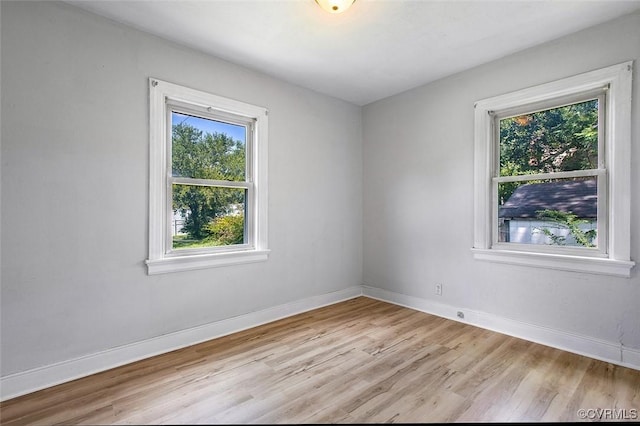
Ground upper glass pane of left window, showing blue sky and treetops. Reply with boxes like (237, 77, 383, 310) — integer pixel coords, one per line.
(171, 111, 247, 181)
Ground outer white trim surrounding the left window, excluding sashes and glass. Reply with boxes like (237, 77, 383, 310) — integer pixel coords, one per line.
(145, 78, 269, 275)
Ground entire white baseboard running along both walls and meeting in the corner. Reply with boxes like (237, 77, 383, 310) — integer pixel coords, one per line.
(0, 286, 640, 401)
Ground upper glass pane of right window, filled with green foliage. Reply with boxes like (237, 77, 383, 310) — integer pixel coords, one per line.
(500, 99, 598, 176)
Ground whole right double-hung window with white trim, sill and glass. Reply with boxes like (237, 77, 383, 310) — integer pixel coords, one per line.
(473, 62, 634, 276)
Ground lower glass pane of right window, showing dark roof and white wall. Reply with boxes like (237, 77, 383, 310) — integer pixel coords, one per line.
(498, 177, 598, 247)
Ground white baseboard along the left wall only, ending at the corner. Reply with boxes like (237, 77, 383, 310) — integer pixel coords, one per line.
(0, 286, 362, 401)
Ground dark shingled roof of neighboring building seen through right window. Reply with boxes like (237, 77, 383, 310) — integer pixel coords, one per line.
(498, 179, 598, 219)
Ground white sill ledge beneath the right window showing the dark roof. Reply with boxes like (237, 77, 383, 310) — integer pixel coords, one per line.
(471, 248, 635, 278)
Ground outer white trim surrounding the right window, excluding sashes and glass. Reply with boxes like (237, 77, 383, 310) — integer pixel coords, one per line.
(472, 61, 635, 277)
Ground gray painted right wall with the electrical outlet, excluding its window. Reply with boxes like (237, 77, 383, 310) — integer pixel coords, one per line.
(363, 13, 640, 348)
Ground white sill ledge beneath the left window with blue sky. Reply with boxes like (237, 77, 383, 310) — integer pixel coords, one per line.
(145, 250, 270, 275)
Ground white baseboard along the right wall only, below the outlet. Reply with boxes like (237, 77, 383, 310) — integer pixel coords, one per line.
(362, 286, 640, 370)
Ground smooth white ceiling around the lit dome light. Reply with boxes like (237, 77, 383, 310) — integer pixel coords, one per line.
(68, 0, 640, 105)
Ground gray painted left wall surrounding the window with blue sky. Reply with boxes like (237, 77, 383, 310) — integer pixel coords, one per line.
(1, 2, 362, 376)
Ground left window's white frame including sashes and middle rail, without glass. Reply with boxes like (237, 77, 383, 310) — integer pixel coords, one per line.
(146, 78, 269, 275)
